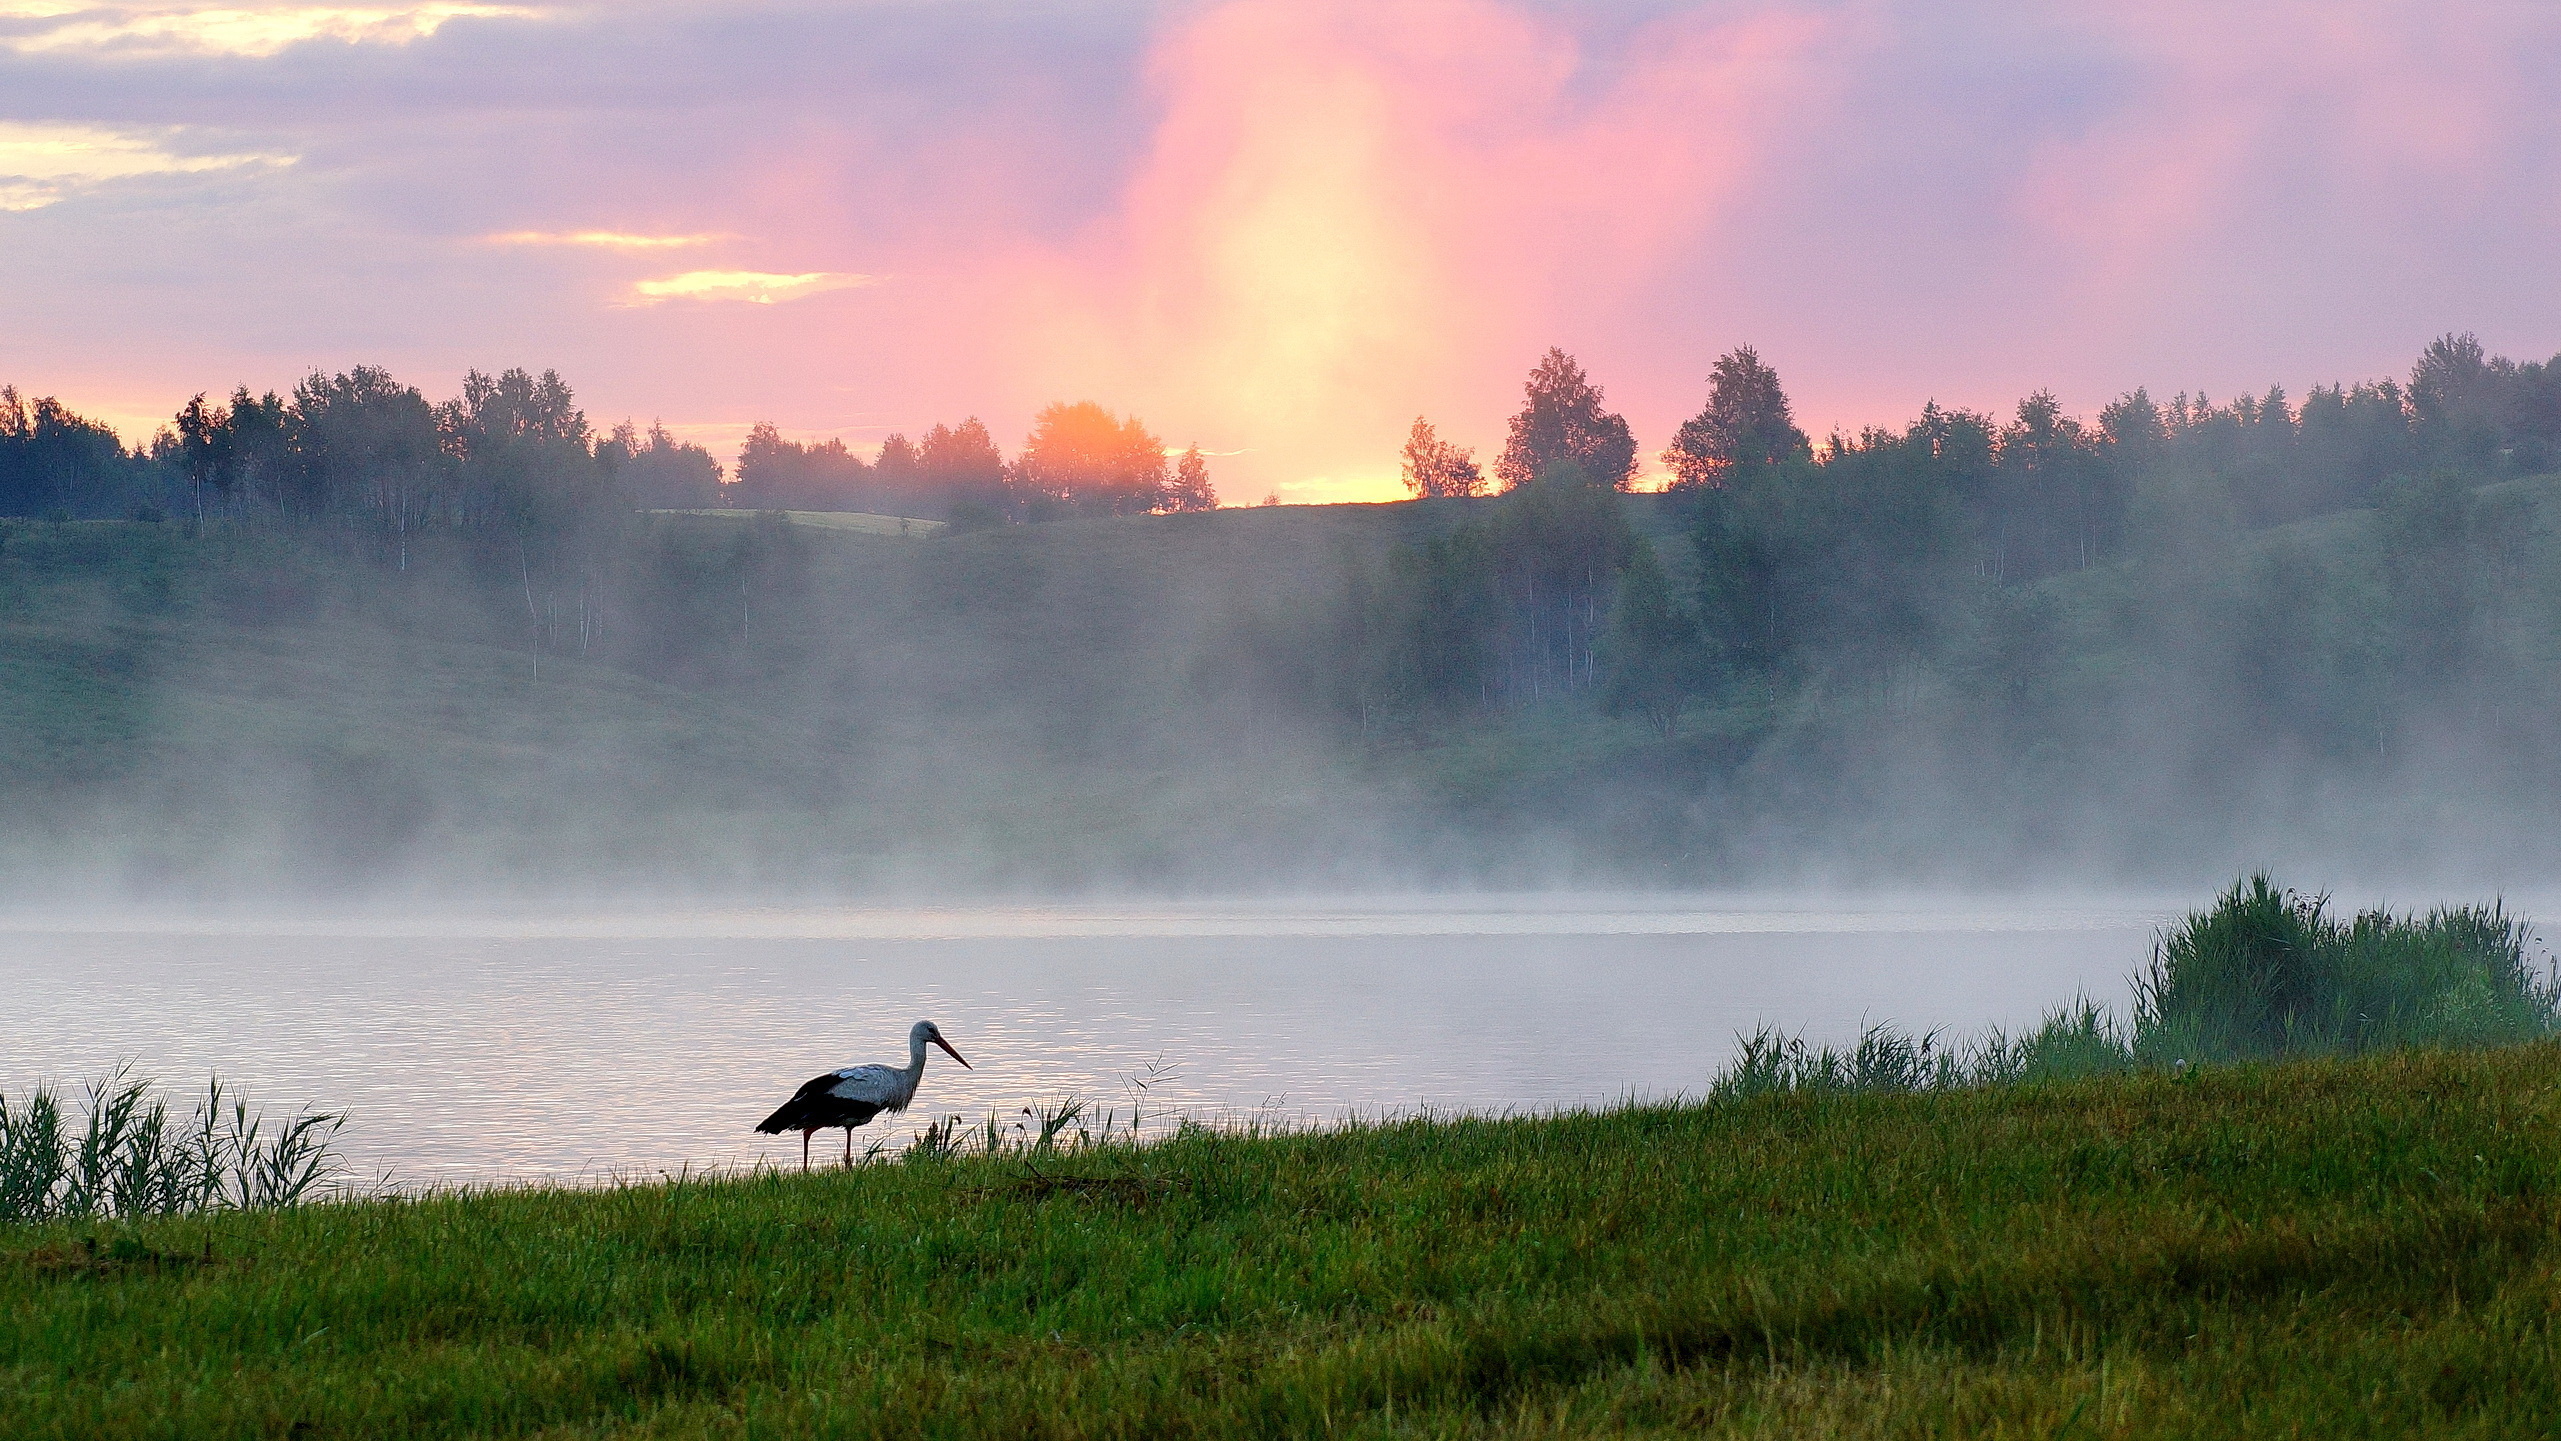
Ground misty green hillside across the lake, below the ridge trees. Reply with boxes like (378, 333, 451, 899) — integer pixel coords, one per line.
(15, 476, 2561, 898)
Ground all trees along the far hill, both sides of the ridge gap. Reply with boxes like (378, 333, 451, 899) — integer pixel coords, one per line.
(0, 325, 2561, 752)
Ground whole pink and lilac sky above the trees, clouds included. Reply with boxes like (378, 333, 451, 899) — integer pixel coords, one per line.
(0, 0, 2561, 502)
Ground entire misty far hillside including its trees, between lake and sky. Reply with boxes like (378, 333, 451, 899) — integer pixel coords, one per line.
(0, 335, 2561, 888)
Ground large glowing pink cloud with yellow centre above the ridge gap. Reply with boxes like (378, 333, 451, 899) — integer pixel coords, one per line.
(962, 0, 1831, 499)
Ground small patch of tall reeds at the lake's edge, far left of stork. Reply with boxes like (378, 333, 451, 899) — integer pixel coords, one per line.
(0, 1067, 346, 1223)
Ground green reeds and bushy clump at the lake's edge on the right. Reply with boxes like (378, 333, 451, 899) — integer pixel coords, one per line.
(1711, 873, 2561, 1098)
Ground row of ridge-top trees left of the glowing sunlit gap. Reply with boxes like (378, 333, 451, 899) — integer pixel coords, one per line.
(0, 366, 1216, 529)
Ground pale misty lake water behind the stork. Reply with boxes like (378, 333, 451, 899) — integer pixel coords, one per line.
(0, 896, 2169, 1182)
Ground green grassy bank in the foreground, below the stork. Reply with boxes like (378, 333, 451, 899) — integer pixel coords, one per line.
(0, 1047, 2561, 1438)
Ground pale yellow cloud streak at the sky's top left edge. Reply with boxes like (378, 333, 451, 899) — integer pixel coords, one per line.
(0, 0, 543, 56)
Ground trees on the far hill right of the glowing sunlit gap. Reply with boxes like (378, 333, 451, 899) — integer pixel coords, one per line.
(1337, 335, 2561, 732)
